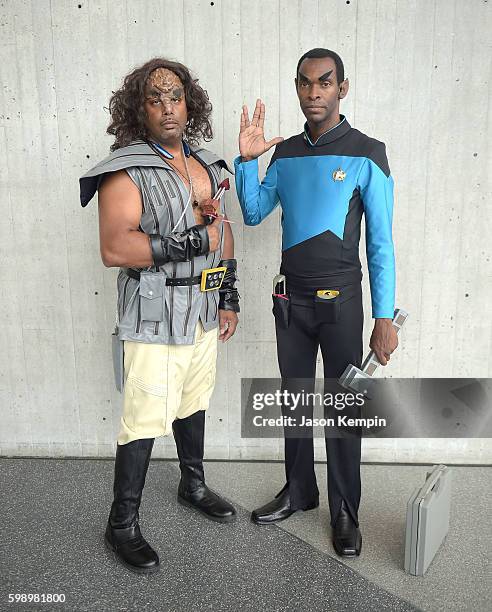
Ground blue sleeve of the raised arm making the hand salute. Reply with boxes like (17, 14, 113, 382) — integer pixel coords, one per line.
(234, 157, 279, 225)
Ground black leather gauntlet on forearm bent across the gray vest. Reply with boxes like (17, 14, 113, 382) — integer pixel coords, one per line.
(149, 225, 210, 267)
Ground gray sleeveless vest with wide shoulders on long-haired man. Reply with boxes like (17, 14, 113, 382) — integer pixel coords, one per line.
(80, 141, 231, 344)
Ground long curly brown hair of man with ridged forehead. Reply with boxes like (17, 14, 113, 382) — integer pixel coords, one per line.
(106, 57, 213, 151)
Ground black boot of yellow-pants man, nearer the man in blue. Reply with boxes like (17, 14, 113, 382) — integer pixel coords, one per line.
(173, 410, 236, 523)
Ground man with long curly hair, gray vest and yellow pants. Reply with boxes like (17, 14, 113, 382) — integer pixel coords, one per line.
(80, 58, 239, 573)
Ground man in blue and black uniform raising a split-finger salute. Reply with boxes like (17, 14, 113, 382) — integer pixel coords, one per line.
(235, 49, 398, 556)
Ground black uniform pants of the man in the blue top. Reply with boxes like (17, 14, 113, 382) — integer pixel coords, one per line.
(275, 285, 363, 526)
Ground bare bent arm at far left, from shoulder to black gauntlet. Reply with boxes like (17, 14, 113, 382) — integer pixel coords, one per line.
(99, 170, 153, 268)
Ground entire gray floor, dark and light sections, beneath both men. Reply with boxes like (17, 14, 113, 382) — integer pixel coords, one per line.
(0, 458, 491, 612)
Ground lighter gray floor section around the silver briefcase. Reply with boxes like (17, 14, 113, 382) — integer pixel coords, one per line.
(207, 463, 492, 612)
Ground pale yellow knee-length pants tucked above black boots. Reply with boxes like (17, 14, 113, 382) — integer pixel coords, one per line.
(117, 321, 218, 445)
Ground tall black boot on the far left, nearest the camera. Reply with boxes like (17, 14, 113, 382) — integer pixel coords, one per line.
(104, 438, 159, 574)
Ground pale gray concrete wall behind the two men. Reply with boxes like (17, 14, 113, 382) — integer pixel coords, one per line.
(0, 0, 492, 463)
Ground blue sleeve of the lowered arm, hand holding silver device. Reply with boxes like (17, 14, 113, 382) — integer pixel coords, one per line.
(359, 148, 395, 319)
